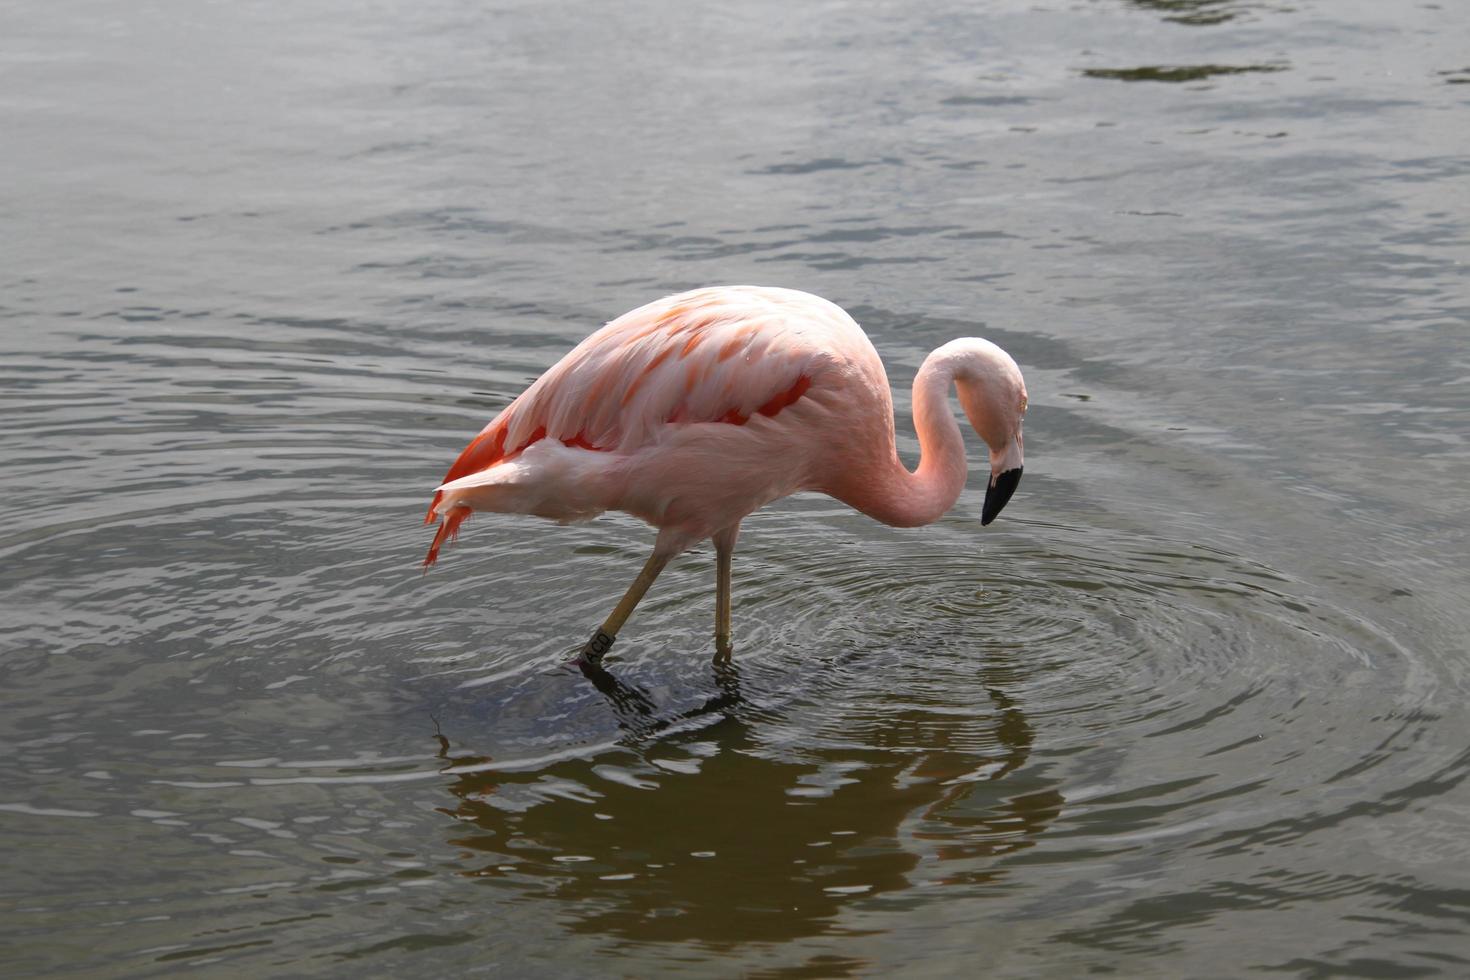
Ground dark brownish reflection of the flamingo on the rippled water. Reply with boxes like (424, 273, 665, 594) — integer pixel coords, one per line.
(426, 646, 1063, 945)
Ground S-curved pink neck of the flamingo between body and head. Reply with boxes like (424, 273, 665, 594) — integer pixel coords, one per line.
(842, 351, 970, 527)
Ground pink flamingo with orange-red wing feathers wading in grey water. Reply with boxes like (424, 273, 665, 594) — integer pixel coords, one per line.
(423, 287, 1026, 667)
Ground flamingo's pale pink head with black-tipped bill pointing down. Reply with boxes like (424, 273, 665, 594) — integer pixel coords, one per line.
(954, 345, 1026, 525)
